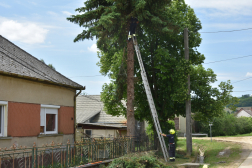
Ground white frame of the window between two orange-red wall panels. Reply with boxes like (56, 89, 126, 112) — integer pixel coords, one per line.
(40, 104, 60, 134)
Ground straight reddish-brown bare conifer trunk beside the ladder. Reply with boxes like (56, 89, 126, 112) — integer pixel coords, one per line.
(127, 39, 135, 137)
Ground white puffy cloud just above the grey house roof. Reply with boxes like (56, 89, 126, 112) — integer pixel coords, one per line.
(0, 18, 48, 44)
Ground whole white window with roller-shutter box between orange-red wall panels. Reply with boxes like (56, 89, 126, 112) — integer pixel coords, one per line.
(40, 104, 60, 134)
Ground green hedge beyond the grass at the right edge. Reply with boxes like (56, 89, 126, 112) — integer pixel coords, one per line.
(197, 113, 252, 136)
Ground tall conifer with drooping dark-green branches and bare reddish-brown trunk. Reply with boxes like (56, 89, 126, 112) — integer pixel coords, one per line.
(67, 0, 175, 136)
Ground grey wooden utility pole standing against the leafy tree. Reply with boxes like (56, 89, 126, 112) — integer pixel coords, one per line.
(184, 28, 192, 156)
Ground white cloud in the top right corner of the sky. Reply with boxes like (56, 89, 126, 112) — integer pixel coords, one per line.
(185, 0, 252, 16)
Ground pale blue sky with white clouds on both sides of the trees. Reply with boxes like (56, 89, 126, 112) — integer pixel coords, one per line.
(0, 0, 252, 97)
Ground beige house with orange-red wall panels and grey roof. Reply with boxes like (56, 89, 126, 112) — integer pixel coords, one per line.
(0, 36, 85, 148)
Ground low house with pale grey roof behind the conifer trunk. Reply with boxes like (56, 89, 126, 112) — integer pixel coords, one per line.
(76, 95, 147, 140)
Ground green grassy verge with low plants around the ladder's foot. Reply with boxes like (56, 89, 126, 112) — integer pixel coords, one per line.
(102, 139, 242, 168)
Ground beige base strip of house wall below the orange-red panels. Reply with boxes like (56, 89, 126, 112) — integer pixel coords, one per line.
(0, 134, 74, 148)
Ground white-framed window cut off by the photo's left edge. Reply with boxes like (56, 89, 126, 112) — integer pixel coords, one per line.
(0, 101, 8, 137)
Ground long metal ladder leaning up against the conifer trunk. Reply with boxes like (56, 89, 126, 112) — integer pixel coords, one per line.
(132, 37, 169, 162)
